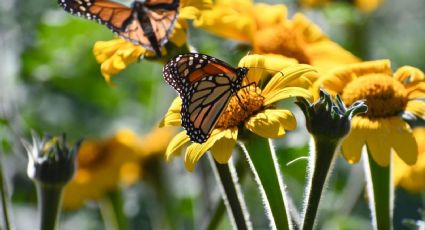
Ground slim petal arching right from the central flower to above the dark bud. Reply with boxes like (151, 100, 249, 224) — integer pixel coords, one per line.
(263, 87, 313, 106)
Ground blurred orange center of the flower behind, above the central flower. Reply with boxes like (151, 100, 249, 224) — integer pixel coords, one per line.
(254, 25, 310, 64)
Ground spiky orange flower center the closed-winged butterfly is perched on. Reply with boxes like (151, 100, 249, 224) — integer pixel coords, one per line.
(216, 86, 264, 129)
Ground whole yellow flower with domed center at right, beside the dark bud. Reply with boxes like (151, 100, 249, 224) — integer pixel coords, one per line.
(315, 60, 425, 166)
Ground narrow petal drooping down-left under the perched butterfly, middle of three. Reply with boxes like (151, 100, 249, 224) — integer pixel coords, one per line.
(184, 129, 225, 172)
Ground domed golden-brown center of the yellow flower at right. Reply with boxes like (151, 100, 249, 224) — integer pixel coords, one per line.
(342, 74, 408, 118)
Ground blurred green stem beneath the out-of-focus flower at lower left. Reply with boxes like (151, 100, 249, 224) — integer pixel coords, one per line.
(99, 188, 128, 230)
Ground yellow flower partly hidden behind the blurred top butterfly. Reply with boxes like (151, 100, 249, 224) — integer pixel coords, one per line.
(93, 0, 211, 82)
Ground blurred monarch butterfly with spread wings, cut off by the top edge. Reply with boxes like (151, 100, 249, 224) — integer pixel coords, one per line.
(58, 0, 179, 57)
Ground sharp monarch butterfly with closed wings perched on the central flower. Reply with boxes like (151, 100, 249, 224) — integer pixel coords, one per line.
(163, 53, 248, 143)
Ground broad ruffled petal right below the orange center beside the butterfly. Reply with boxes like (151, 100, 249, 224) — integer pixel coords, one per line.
(245, 109, 297, 138)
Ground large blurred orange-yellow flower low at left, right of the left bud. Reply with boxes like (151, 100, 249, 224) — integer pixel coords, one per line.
(63, 129, 174, 209)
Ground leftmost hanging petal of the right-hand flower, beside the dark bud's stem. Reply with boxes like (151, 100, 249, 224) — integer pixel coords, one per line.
(342, 126, 365, 164)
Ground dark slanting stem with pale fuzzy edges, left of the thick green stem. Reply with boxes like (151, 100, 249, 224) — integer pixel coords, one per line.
(209, 156, 251, 230)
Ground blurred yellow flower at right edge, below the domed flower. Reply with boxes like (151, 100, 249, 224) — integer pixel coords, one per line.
(394, 128, 425, 192)
